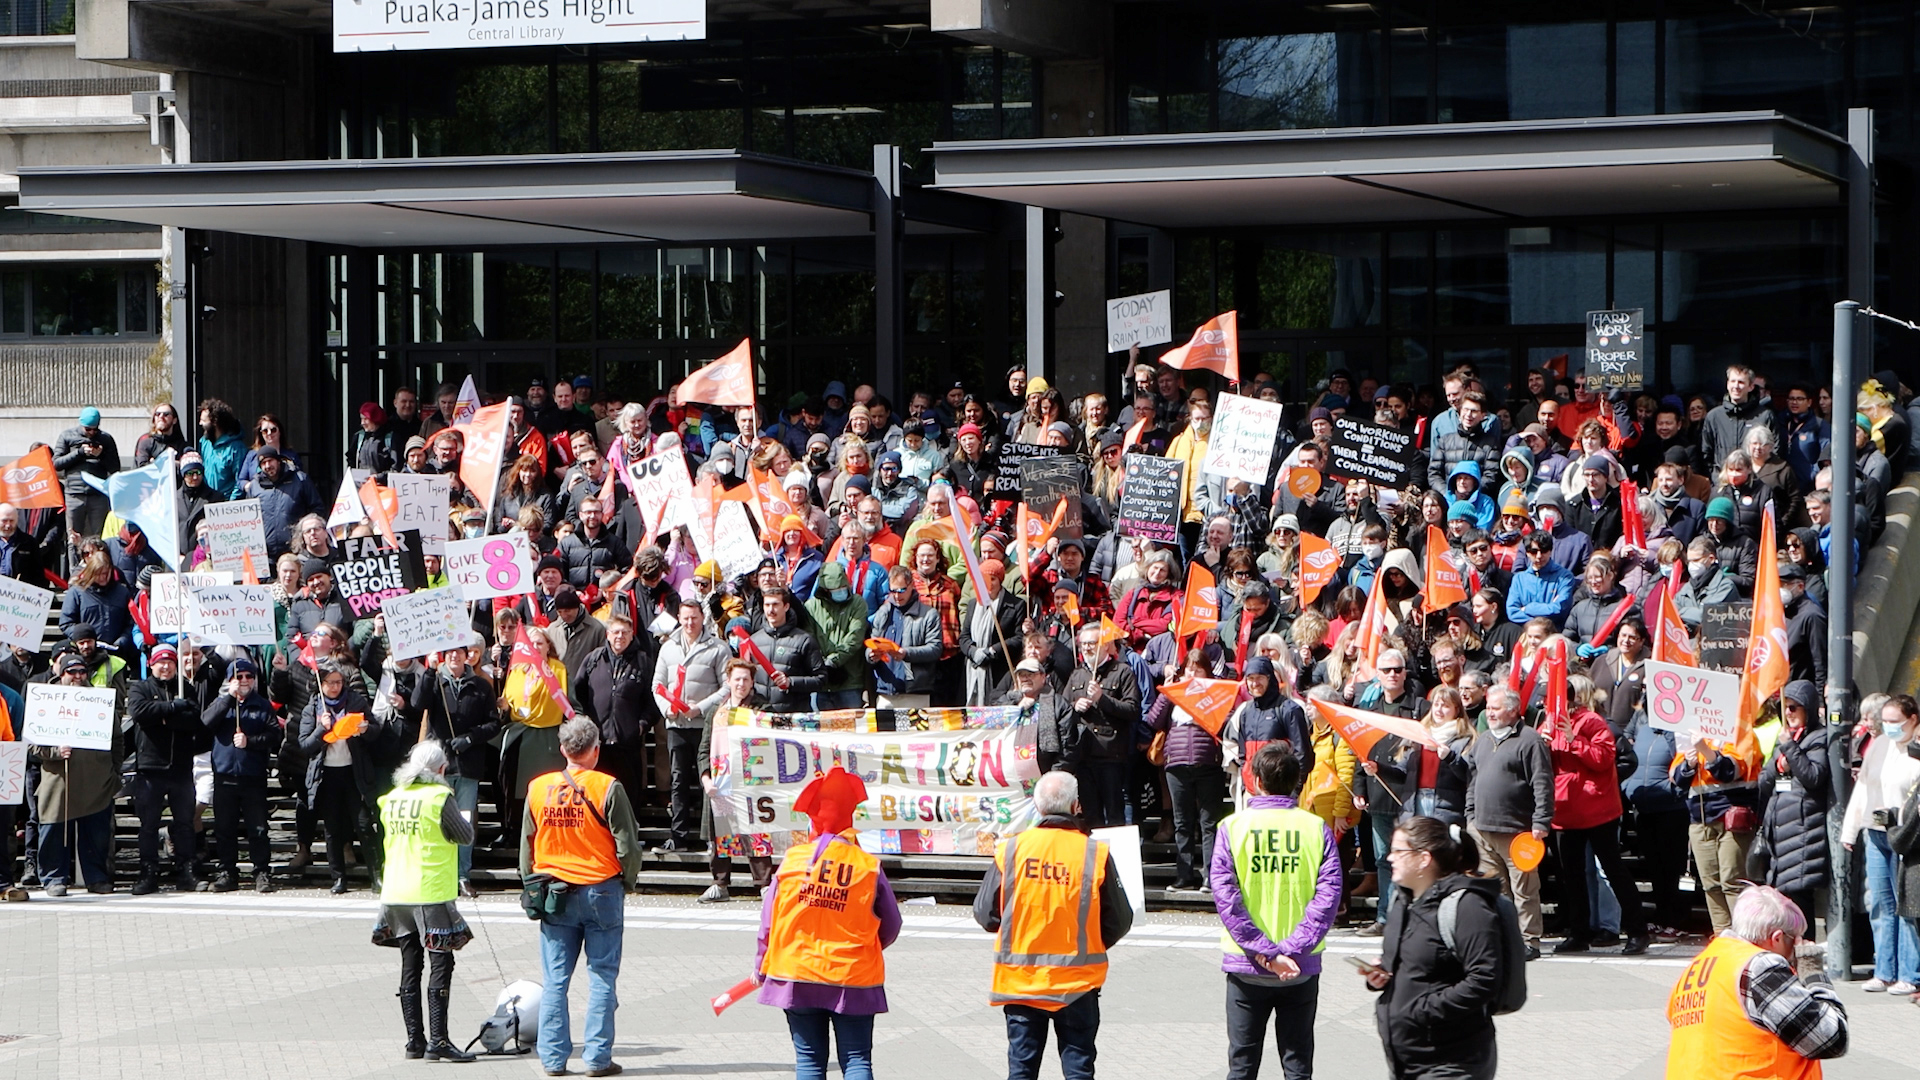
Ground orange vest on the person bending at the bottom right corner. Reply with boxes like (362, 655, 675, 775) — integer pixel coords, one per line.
(1667, 936, 1820, 1080)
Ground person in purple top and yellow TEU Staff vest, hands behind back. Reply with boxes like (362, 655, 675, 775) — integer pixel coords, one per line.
(1210, 742, 1340, 1080)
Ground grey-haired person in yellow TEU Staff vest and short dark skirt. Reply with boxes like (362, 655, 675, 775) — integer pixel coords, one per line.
(372, 738, 474, 1061)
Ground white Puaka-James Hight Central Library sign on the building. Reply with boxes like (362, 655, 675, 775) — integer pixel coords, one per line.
(334, 0, 707, 52)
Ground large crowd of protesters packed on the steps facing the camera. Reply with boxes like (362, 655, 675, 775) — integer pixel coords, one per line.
(0, 349, 1920, 1030)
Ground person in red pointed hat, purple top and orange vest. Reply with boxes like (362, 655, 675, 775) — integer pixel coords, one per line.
(758, 767, 900, 1080)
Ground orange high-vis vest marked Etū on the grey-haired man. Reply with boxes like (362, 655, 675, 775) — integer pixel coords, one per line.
(989, 828, 1106, 1013)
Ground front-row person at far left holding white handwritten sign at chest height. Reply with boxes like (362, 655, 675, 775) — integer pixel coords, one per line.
(27, 651, 127, 897)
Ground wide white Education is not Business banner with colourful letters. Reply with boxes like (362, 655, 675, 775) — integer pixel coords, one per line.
(710, 709, 1039, 855)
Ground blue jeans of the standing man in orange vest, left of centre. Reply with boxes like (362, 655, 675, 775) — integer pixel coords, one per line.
(540, 878, 626, 1070)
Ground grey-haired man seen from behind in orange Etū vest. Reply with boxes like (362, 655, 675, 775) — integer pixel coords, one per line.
(973, 773, 1133, 1080)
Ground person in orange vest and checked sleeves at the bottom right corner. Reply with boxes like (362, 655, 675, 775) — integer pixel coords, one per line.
(1667, 886, 1847, 1080)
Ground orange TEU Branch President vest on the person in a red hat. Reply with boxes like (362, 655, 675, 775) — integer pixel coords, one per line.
(760, 832, 887, 988)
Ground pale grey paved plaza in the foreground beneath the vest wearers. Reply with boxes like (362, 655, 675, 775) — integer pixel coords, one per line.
(0, 892, 1920, 1080)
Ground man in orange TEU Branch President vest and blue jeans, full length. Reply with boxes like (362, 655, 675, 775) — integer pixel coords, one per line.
(520, 717, 641, 1076)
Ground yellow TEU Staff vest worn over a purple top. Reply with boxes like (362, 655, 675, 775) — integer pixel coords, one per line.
(1219, 807, 1327, 957)
